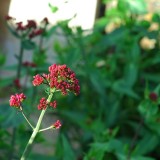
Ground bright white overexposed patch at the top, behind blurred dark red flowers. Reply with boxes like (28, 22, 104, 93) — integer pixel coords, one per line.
(9, 0, 97, 29)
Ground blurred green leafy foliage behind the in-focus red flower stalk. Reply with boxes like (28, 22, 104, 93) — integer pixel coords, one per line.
(0, 0, 160, 160)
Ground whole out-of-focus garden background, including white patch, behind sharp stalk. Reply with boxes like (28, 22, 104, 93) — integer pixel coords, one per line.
(0, 0, 160, 160)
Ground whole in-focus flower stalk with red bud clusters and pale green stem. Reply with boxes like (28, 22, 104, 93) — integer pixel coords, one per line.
(9, 64, 80, 160)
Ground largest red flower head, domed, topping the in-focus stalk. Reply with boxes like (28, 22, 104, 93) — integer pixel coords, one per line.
(33, 64, 80, 95)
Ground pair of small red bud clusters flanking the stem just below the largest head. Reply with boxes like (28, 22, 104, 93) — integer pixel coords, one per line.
(38, 97, 57, 110)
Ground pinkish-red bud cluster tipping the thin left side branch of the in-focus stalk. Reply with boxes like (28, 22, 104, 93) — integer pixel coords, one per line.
(9, 93, 26, 108)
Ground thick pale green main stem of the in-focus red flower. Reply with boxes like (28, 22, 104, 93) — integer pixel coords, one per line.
(20, 92, 53, 160)
